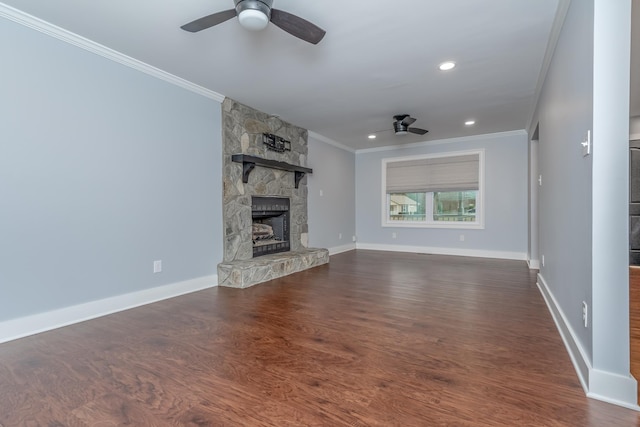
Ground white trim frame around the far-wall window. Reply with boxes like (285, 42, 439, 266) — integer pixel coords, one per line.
(381, 149, 485, 229)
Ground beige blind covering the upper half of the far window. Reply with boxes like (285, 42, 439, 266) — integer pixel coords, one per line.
(387, 154, 480, 193)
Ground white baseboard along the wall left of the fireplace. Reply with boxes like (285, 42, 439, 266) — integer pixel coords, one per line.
(0, 275, 218, 343)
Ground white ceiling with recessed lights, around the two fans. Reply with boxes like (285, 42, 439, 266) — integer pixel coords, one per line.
(2, 0, 566, 149)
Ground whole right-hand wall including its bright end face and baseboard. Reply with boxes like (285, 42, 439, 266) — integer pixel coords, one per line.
(530, 0, 635, 404)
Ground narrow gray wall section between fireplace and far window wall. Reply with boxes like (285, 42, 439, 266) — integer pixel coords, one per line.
(307, 134, 356, 253)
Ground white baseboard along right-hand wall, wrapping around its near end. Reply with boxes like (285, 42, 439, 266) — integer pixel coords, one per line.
(538, 274, 640, 411)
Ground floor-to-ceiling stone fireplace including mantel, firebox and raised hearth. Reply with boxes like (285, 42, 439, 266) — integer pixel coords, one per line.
(218, 98, 329, 288)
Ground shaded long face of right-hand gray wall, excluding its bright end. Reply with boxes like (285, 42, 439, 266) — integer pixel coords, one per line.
(534, 1, 593, 353)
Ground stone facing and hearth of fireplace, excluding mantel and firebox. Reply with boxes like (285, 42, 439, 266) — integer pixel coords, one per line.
(218, 98, 329, 288)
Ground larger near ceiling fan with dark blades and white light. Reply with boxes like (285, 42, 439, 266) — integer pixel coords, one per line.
(180, 0, 326, 44)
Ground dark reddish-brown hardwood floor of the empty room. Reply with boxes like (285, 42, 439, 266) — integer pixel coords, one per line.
(0, 251, 640, 427)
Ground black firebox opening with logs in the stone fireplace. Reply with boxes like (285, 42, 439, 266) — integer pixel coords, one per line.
(251, 196, 291, 258)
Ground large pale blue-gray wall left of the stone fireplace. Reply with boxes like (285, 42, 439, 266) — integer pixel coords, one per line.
(0, 19, 222, 321)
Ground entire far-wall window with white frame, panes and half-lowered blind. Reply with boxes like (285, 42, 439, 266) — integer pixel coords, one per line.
(382, 151, 484, 228)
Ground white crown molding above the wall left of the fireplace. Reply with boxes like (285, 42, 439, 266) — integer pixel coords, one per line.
(0, 3, 224, 102)
